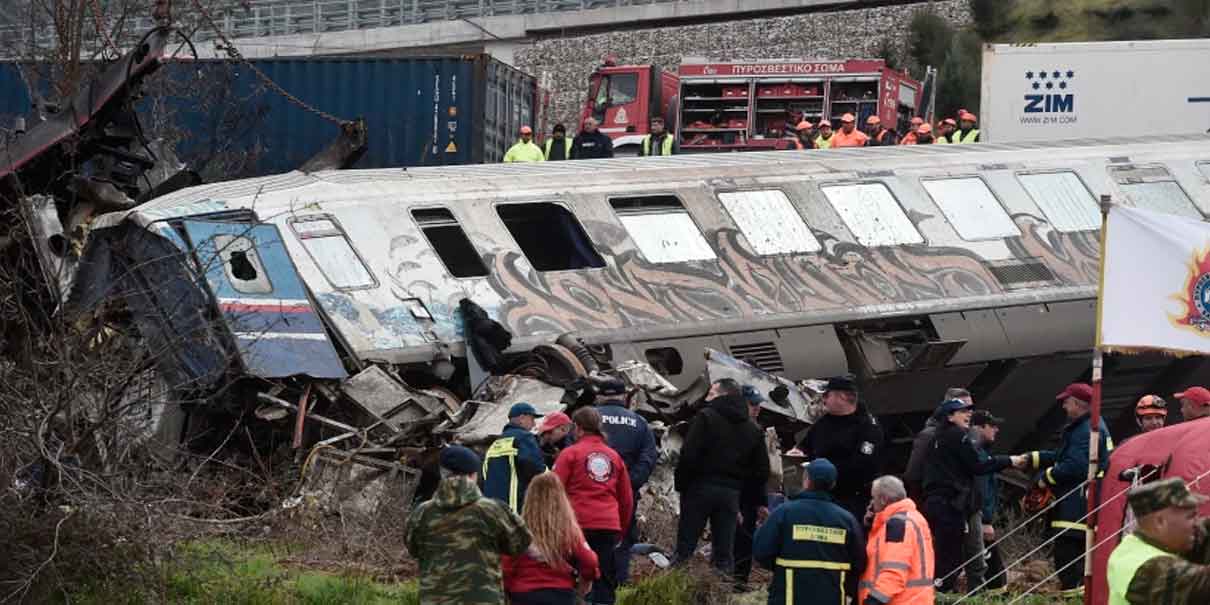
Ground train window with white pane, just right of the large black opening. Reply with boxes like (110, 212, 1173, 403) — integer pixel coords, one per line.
(609, 195, 715, 263)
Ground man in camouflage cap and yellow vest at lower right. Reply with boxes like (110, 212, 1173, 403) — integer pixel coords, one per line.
(1106, 477, 1210, 605)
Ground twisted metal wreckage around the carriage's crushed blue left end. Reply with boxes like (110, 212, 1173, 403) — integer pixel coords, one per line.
(0, 29, 819, 513)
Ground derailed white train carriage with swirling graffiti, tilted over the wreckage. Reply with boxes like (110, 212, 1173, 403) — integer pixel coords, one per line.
(70, 137, 1210, 448)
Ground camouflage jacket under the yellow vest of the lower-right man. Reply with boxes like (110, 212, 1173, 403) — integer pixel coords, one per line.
(1127, 519, 1210, 605)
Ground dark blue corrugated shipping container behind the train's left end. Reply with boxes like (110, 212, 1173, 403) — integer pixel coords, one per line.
(0, 54, 537, 178)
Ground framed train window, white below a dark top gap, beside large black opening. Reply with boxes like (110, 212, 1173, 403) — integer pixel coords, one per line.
(609, 192, 719, 265)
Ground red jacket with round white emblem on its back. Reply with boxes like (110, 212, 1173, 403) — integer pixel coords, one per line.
(554, 434, 634, 531)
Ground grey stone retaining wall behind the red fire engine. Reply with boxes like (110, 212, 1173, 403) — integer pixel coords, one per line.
(512, 0, 972, 129)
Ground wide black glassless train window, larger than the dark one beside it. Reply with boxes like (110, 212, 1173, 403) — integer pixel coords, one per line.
(496, 202, 605, 271)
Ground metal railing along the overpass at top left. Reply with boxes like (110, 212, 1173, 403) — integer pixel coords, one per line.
(0, 0, 701, 54)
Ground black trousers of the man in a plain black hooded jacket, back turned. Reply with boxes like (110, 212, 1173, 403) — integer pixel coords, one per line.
(676, 483, 739, 576)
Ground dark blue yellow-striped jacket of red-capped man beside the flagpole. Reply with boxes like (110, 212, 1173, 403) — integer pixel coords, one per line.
(1030, 414, 1113, 530)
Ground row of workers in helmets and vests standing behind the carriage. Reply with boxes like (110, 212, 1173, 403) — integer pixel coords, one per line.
(503, 109, 979, 162)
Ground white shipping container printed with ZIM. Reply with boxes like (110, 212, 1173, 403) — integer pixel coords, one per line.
(979, 40, 1210, 143)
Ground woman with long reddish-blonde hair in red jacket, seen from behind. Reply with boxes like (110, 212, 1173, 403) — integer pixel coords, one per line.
(501, 472, 600, 605)
